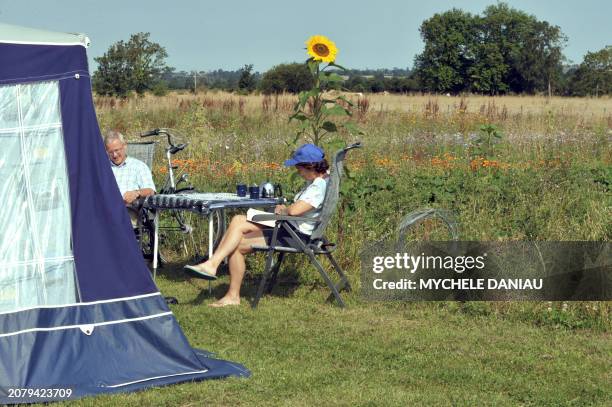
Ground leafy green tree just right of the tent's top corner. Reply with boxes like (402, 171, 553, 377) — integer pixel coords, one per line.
(93, 33, 172, 97)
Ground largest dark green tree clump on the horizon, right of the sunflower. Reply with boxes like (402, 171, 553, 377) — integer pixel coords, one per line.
(415, 3, 566, 94)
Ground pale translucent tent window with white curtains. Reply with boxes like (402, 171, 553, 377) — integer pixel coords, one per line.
(0, 82, 77, 312)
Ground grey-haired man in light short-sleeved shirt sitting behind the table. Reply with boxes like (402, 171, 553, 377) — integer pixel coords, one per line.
(104, 130, 155, 214)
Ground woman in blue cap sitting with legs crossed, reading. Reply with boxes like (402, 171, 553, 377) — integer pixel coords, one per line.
(185, 144, 329, 307)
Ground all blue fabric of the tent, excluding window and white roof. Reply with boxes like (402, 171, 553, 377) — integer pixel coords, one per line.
(0, 28, 250, 404)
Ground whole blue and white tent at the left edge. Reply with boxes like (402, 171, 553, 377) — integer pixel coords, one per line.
(0, 24, 249, 403)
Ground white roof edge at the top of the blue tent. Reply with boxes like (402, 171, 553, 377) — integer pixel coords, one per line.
(0, 23, 90, 48)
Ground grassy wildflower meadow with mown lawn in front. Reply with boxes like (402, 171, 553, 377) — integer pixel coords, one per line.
(76, 93, 612, 405)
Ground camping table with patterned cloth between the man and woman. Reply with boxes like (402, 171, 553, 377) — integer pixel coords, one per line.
(143, 192, 282, 279)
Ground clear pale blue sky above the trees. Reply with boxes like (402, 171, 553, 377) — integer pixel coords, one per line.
(0, 0, 612, 72)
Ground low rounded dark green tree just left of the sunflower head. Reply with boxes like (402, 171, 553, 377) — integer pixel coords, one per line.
(260, 63, 314, 94)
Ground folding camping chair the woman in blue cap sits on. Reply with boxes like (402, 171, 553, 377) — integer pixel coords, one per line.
(252, 143, 361, 308)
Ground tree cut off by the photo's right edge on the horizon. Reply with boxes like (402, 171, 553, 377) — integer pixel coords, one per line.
(570, 45, 612, 96)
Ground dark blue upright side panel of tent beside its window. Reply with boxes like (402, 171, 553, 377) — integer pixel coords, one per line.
(60, 68, 157, 301)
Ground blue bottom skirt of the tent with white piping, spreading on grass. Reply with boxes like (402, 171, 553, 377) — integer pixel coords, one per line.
(0, 294, 249, 403)
